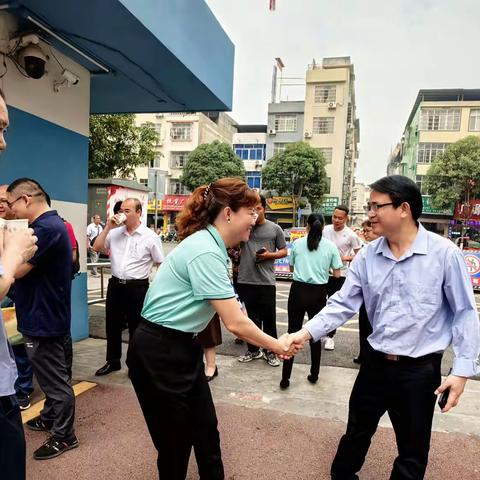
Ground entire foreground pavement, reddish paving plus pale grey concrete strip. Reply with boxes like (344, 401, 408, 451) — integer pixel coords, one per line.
(21, 339, 480, 480)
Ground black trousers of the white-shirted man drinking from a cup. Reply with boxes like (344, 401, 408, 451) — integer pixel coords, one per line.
(105, 278, 148, 364)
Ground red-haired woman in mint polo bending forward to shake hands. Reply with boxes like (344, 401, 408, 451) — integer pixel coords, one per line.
(127, 178, 294, 480)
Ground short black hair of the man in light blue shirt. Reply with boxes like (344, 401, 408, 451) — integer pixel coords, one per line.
(370, 175, 423, 222)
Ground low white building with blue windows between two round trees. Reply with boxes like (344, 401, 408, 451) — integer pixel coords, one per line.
(233, 125, 267, 190)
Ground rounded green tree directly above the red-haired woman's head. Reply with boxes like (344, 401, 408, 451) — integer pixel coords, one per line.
(180, 140, 245, 192)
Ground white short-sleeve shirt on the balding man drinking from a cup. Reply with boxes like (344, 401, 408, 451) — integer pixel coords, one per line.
(105, 224, 164, 280)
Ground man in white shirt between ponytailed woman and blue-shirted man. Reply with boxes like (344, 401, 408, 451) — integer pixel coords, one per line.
(323, 205, 362, 350)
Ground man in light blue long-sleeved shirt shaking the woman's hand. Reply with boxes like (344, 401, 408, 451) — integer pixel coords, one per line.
(293, 175, 480, 480)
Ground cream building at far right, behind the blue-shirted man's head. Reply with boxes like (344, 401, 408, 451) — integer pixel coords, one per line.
(387, 89, 480, 234)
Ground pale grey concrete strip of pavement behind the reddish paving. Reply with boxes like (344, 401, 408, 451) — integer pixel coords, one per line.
(73, 338, 480, 438)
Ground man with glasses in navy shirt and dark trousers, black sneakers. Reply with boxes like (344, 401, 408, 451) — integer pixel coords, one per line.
(7, 178, 78, 460)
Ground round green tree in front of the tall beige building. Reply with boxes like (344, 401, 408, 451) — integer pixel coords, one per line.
(262, 142, 327, 208)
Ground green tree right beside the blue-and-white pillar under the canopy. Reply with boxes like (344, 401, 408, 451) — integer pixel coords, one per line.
(88, 114, 158, 178)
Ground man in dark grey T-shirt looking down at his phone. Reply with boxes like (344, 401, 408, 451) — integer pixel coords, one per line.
(237, 195, 288, 367)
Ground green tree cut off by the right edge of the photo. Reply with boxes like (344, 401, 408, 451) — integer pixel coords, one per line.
(425, 135, 480, 208)
